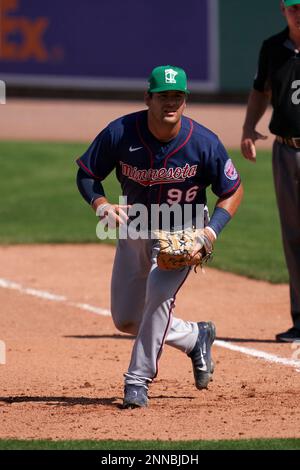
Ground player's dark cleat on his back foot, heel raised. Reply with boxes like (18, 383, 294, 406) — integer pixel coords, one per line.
(188, 322, 216, 390)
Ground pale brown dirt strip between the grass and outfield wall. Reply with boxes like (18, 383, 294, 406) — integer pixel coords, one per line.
(0, 100, 272, 148)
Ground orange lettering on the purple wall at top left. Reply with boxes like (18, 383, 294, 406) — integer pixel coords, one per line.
(0, 0, 49, 62)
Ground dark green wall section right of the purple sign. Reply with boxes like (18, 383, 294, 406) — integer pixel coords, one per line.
(219, 0, 286, 92)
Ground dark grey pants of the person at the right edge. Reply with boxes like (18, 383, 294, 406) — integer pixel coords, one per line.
(273, 141, 300, 329)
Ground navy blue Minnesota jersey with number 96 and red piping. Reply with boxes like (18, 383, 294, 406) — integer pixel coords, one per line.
(77, 110, 240, 207)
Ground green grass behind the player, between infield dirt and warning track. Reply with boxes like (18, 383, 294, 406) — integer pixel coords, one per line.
(0, 142, 287, 282)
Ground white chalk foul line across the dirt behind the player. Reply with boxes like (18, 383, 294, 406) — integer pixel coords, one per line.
(0, 278, 300, 372)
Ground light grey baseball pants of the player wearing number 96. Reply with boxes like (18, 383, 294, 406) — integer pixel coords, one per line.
(111, 239, 198, 385)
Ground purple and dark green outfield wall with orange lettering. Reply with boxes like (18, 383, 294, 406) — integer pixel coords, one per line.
(0, 0, 284, 93)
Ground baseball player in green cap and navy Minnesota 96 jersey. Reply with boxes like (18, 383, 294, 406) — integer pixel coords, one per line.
(77, 65, 242, 408)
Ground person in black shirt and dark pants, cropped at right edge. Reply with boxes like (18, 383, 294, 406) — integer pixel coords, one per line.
(241, 0, 300, 342)
